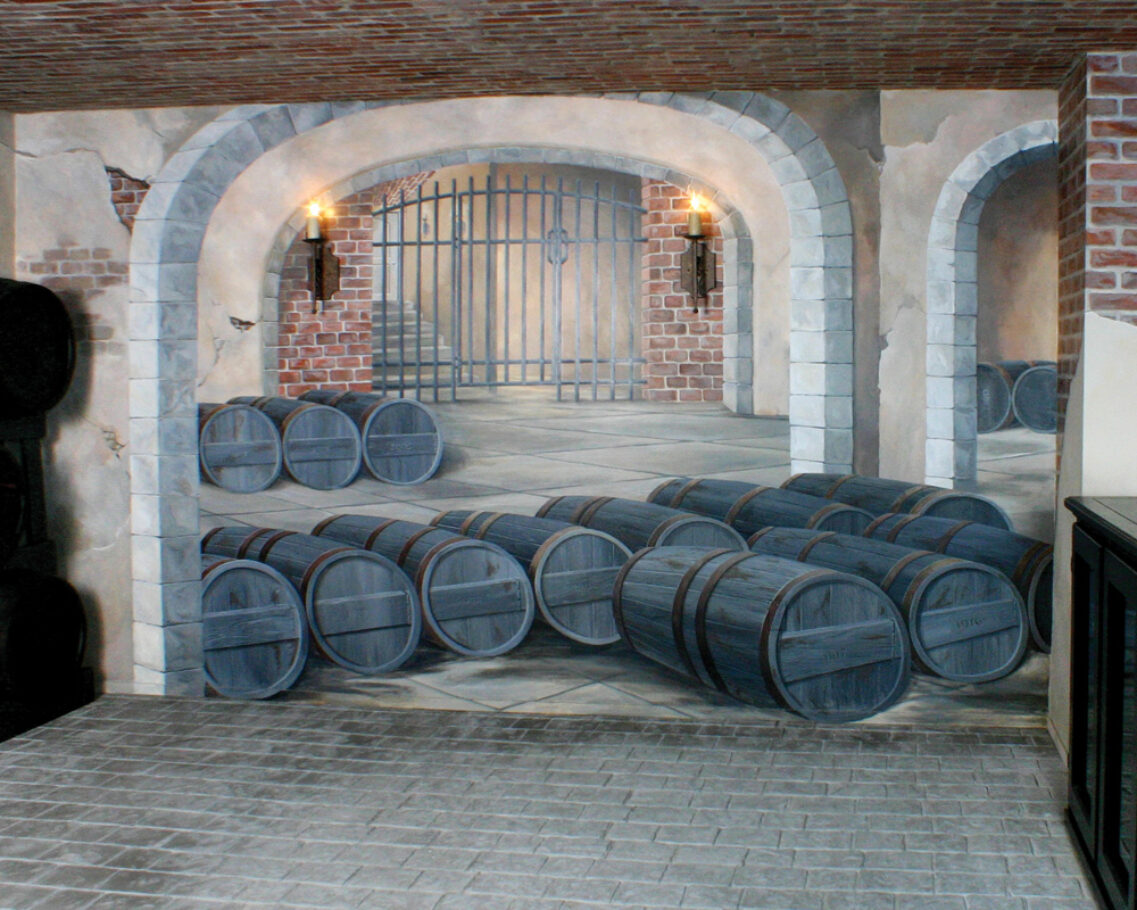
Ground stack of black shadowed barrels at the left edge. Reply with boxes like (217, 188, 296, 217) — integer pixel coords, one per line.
(0, 279, 94, 739)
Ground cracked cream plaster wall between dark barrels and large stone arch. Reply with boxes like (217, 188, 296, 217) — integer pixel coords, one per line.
(13, 109, 216, 692)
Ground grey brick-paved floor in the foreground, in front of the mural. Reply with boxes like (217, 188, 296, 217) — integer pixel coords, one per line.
(0, 696, 1093, 910)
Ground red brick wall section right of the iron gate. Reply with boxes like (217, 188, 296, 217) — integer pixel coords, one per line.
(642, 179, 722, 402)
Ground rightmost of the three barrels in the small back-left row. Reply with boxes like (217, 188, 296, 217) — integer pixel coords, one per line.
(300, 389, 442, 485)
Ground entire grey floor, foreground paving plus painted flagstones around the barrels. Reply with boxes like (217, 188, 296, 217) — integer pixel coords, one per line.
(0, 396, 1093, 910)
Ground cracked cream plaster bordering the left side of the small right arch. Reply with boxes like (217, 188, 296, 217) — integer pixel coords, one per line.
(880, 90, 1057, 482)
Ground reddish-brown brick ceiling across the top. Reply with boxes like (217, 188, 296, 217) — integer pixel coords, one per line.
(0, 0, 1137, 111)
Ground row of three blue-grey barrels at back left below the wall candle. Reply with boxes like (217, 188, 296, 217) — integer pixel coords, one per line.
(198, 390, 442, 493)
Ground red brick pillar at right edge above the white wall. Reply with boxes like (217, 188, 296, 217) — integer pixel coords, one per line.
(1059, 53, 1137, 427)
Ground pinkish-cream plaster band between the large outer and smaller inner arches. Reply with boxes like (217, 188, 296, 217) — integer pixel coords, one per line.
(198, 98, 789, 414)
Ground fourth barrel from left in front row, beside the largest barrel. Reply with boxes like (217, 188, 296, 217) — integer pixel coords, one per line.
(431, 511, 632, 646)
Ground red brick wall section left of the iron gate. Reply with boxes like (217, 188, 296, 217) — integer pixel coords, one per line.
(277, 173, 430, 398)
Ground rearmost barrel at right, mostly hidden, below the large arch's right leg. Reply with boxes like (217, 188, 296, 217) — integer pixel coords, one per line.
(782, 473, 1014, 531)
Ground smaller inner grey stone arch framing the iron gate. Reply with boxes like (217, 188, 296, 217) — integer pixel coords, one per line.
(262, 147, 754, 393)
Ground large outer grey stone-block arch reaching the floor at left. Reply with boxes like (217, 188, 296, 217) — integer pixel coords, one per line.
(128, 92, 853, 694)
